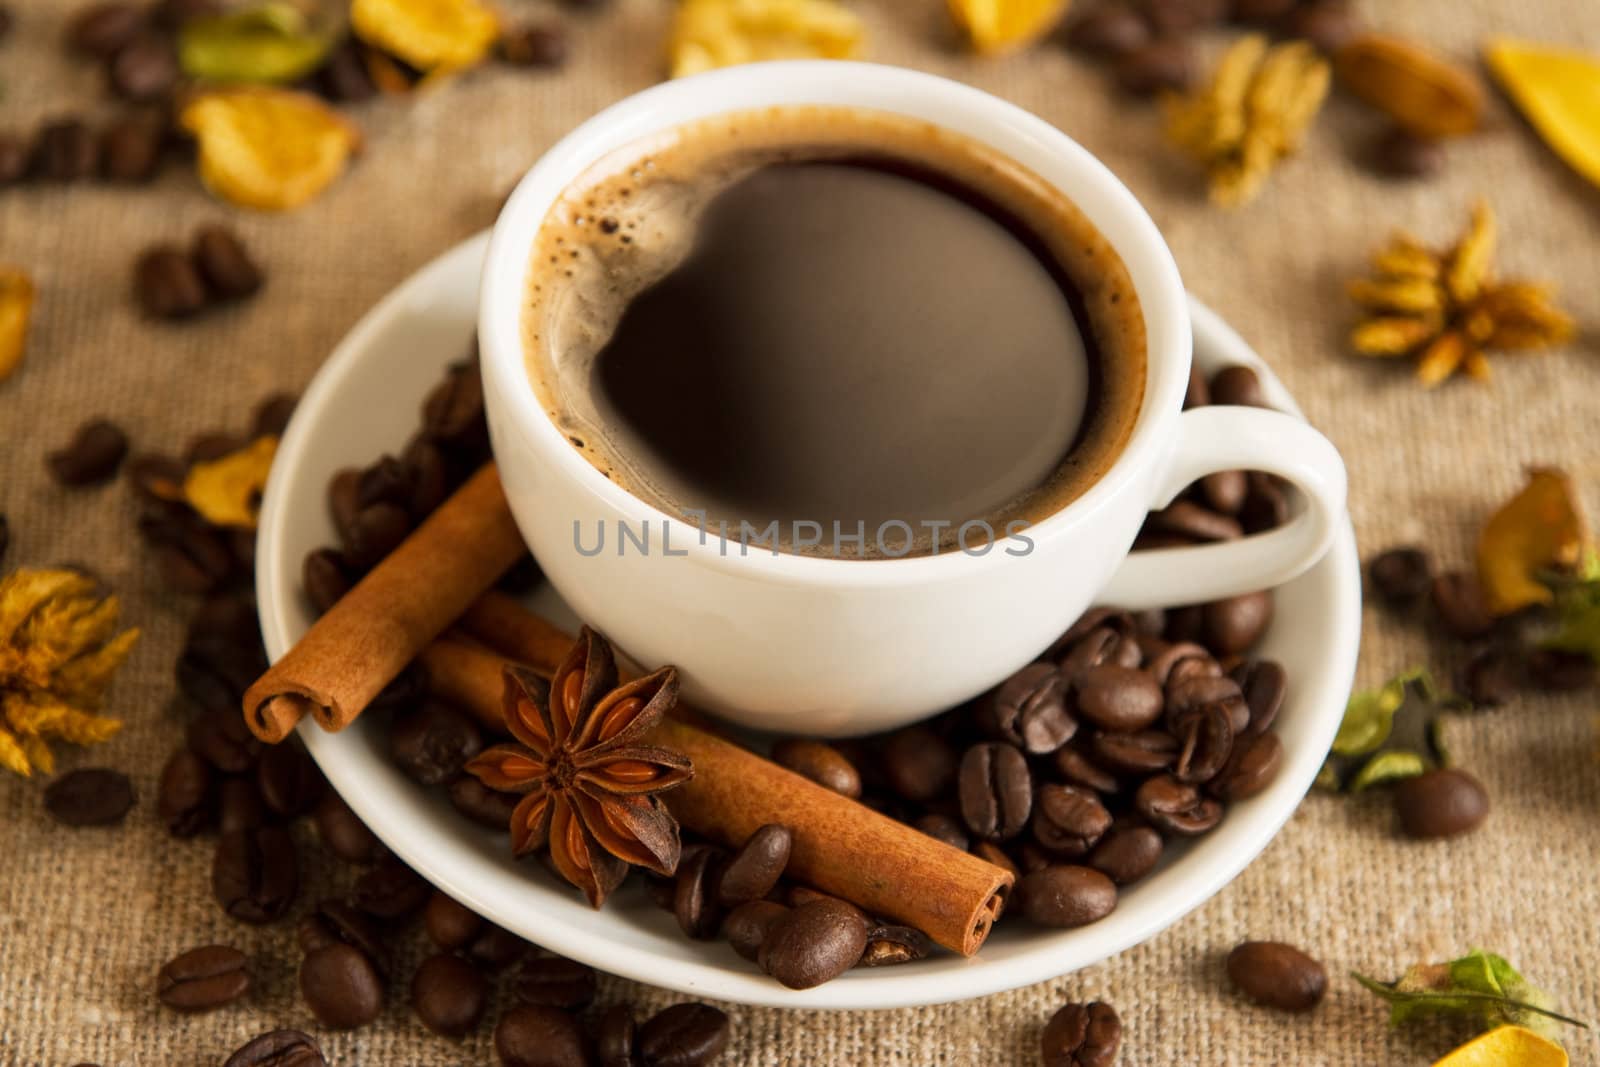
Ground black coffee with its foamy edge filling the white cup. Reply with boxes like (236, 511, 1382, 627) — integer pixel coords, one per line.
(528, 109, 1144, 557)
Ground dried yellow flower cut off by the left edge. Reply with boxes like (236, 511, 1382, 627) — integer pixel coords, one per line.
(0, 569, 139, 776)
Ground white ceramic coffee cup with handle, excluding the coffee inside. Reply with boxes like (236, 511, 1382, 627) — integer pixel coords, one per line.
(478, 61, 1344, 734)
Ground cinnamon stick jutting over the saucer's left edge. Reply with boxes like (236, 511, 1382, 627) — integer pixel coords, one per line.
(243, 464, 526, 744)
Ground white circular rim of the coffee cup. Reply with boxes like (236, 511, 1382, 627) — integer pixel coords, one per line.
(478, 59, 1192, 587)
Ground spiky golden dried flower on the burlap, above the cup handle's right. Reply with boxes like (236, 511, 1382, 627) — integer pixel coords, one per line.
(1349, 203, 1573, 387)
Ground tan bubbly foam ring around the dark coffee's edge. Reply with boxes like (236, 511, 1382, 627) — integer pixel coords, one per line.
(522, 106, 1147, 557)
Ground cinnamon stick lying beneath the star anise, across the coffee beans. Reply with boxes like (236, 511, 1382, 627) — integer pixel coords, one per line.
(422, 630, 1013, 955)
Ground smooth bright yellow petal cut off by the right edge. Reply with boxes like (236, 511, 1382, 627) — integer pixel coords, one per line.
(1483, 37, 1600, 186)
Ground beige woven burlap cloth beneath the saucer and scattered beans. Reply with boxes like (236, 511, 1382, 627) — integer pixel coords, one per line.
(0, 0, 1600, 1067)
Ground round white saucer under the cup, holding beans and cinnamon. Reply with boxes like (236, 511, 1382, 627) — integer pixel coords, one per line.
(256, 234, 1360, 1008)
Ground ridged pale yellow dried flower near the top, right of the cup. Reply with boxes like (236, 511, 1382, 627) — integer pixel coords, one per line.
(1165, 34, 1330, 206)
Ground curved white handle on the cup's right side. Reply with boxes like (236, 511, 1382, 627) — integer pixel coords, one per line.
(1094, 405, 1346, 611)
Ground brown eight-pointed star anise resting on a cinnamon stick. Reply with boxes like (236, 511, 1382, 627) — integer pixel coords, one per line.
(467, 627, 694, 907)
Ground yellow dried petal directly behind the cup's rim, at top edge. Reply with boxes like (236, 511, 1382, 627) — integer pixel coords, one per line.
(667, 0, 866, 78)
